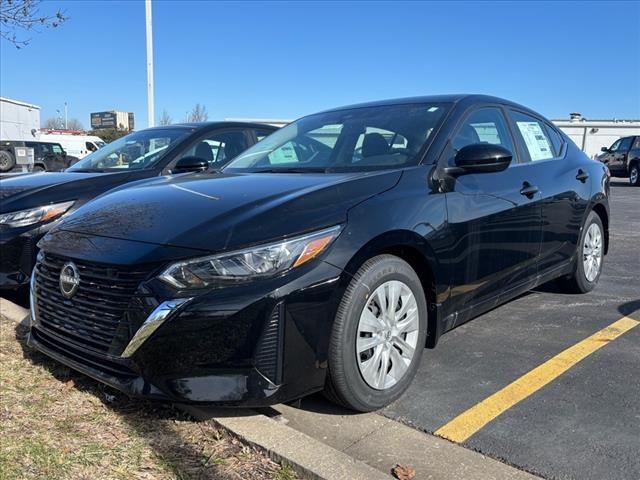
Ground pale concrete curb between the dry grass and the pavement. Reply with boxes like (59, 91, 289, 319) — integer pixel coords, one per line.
(0, 297, 391, 480)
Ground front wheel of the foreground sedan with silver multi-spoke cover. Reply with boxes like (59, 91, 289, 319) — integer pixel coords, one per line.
(325, 255, 427, 412)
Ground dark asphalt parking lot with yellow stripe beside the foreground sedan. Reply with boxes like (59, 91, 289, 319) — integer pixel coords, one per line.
(382, 181, 640, 479)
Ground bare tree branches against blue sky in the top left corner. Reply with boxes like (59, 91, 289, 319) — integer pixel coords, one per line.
(0, 0, 67, 48)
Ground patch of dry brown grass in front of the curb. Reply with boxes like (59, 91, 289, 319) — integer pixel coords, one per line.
(0, 315, 296, 480)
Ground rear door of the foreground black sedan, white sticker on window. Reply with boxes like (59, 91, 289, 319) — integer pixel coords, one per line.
(509, 109, 592, 275)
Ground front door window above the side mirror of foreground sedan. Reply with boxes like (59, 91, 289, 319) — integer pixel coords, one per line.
(452, 107, 516, 159)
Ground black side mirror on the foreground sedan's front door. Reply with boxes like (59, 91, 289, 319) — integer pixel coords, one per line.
(445, 143, 513, 176)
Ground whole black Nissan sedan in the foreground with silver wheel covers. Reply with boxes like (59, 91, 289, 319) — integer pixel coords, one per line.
(29, 96, 609, 411)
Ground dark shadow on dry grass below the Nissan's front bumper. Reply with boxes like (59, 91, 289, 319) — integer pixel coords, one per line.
(15, 315, 242, 480)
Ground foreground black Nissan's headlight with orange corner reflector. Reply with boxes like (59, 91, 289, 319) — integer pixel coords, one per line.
(160, 226, 342, 289)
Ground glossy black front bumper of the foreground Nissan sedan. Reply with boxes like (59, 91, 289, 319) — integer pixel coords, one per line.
(28, 253, 343, 407)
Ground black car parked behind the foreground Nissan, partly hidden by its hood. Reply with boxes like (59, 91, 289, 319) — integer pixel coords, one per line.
(0, 122, 275, 289)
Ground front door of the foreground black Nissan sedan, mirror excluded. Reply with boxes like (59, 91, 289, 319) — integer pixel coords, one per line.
(440, 106, 541, 321)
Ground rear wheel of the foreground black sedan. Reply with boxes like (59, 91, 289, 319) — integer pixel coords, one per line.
(560, 211, 604, 293)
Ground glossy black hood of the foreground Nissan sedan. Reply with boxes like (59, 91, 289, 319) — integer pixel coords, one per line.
(57, 170, 401, 252)
